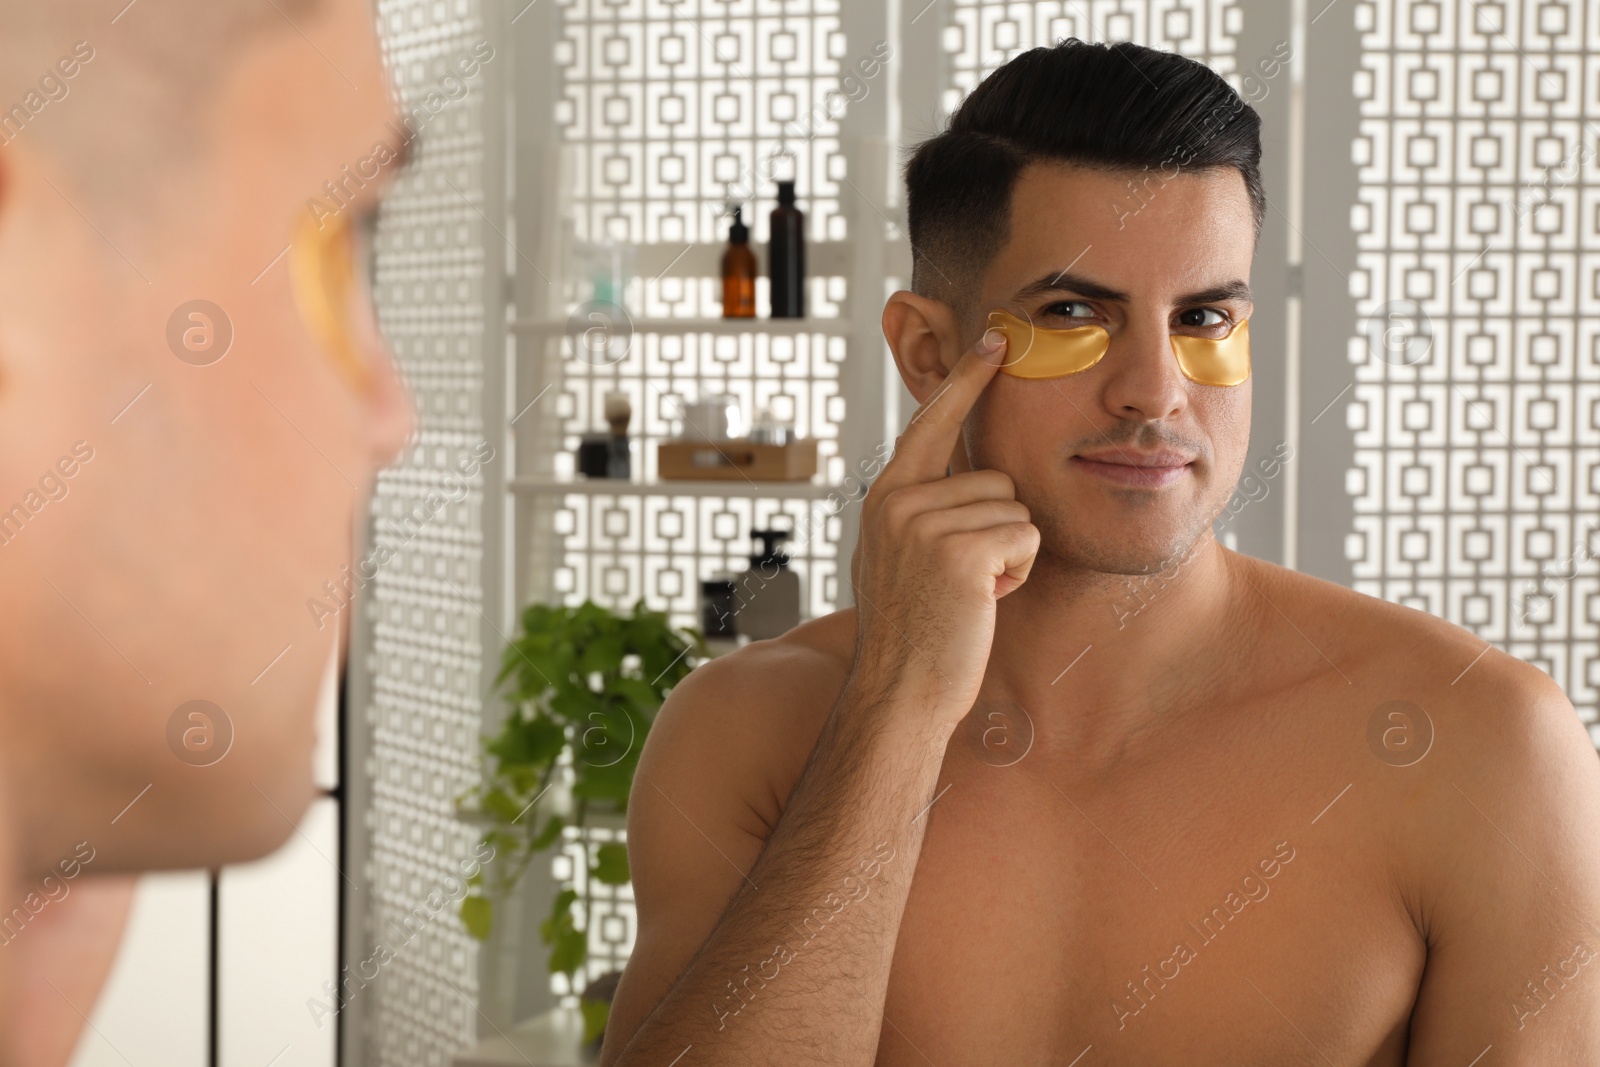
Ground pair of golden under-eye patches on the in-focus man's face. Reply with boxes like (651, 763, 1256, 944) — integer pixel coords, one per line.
(989, 309, 1250, 386)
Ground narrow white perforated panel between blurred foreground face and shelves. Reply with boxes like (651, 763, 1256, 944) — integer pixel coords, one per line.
(352, 0, 509, 1067)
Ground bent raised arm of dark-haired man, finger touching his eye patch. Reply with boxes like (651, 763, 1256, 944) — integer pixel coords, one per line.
(605, 329, 1038, 1067)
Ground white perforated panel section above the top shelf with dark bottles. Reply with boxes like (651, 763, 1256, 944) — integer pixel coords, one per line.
(557, 0, 846, 255)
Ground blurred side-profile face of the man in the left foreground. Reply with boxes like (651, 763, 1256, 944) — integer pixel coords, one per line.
(0, 0, 413, 869)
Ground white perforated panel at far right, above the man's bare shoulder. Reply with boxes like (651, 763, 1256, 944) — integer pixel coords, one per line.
(1346, 0, 1600, 742)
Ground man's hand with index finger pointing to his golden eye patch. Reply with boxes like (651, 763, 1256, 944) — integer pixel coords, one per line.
(851, 331, 1038, 729)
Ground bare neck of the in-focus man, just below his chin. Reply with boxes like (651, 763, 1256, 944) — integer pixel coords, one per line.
(981, 530, 1253, 755)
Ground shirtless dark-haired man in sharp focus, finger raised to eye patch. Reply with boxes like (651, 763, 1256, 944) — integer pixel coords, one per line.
(603, 42, 1600, 1067)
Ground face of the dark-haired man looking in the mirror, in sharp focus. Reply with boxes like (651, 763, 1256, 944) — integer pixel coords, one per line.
(965, 165, 1254, 574)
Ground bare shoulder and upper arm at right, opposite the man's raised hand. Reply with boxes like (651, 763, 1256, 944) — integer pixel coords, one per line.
(1237, 560, 1600, 1064)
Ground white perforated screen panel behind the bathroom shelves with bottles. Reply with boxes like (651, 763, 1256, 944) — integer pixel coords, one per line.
(496, 0, 886, 1009)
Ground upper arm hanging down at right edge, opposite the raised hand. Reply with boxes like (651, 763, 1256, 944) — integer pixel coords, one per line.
(1402, 653, 1600, 1067)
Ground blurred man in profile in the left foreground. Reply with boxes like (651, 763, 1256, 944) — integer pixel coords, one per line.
(0, 0, 413, 1065)
